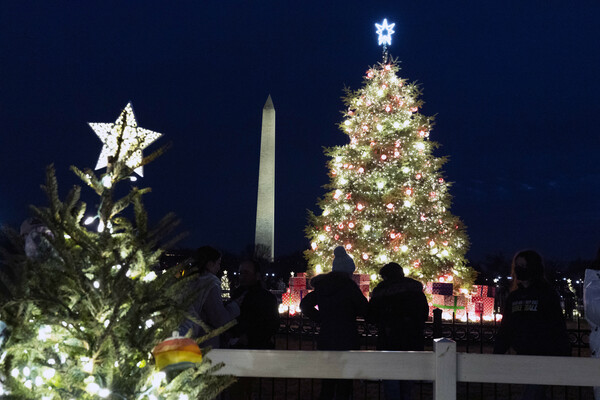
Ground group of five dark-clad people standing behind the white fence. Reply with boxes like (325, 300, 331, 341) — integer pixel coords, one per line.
(179, 246, 596, 400)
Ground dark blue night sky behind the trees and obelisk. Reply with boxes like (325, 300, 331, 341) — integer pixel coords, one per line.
(0, 0, 600, 260)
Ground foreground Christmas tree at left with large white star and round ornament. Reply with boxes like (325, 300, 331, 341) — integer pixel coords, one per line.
(0, 104, 231, 400)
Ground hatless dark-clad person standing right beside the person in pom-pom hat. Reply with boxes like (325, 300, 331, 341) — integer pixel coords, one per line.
(367, 263, 429, 400)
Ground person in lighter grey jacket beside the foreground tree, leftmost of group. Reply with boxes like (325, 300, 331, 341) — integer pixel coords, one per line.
(179, 246, 240, 348)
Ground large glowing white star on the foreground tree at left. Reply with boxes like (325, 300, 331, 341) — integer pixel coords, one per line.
(89, 103, 162, 176)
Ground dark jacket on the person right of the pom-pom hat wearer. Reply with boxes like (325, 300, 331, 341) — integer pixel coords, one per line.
(367, 278, 429, 351)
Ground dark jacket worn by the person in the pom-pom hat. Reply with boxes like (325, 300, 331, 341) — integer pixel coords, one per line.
(300, 272, 368, 350)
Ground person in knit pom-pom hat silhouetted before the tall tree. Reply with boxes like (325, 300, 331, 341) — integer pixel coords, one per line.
(300, 246, 368, 400)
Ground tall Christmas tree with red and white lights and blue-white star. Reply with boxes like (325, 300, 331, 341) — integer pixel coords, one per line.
(305, 20, 474, 288)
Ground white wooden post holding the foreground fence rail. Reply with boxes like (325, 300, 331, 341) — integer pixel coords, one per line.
(433, 338, 456, 400)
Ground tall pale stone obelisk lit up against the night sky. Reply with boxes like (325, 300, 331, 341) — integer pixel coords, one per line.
(254, 95, 275, 260)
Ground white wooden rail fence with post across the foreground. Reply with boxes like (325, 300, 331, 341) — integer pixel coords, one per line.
(208, 339, 600, 400)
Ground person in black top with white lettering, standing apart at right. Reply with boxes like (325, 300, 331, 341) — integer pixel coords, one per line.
(494, 250, 571, 400)
